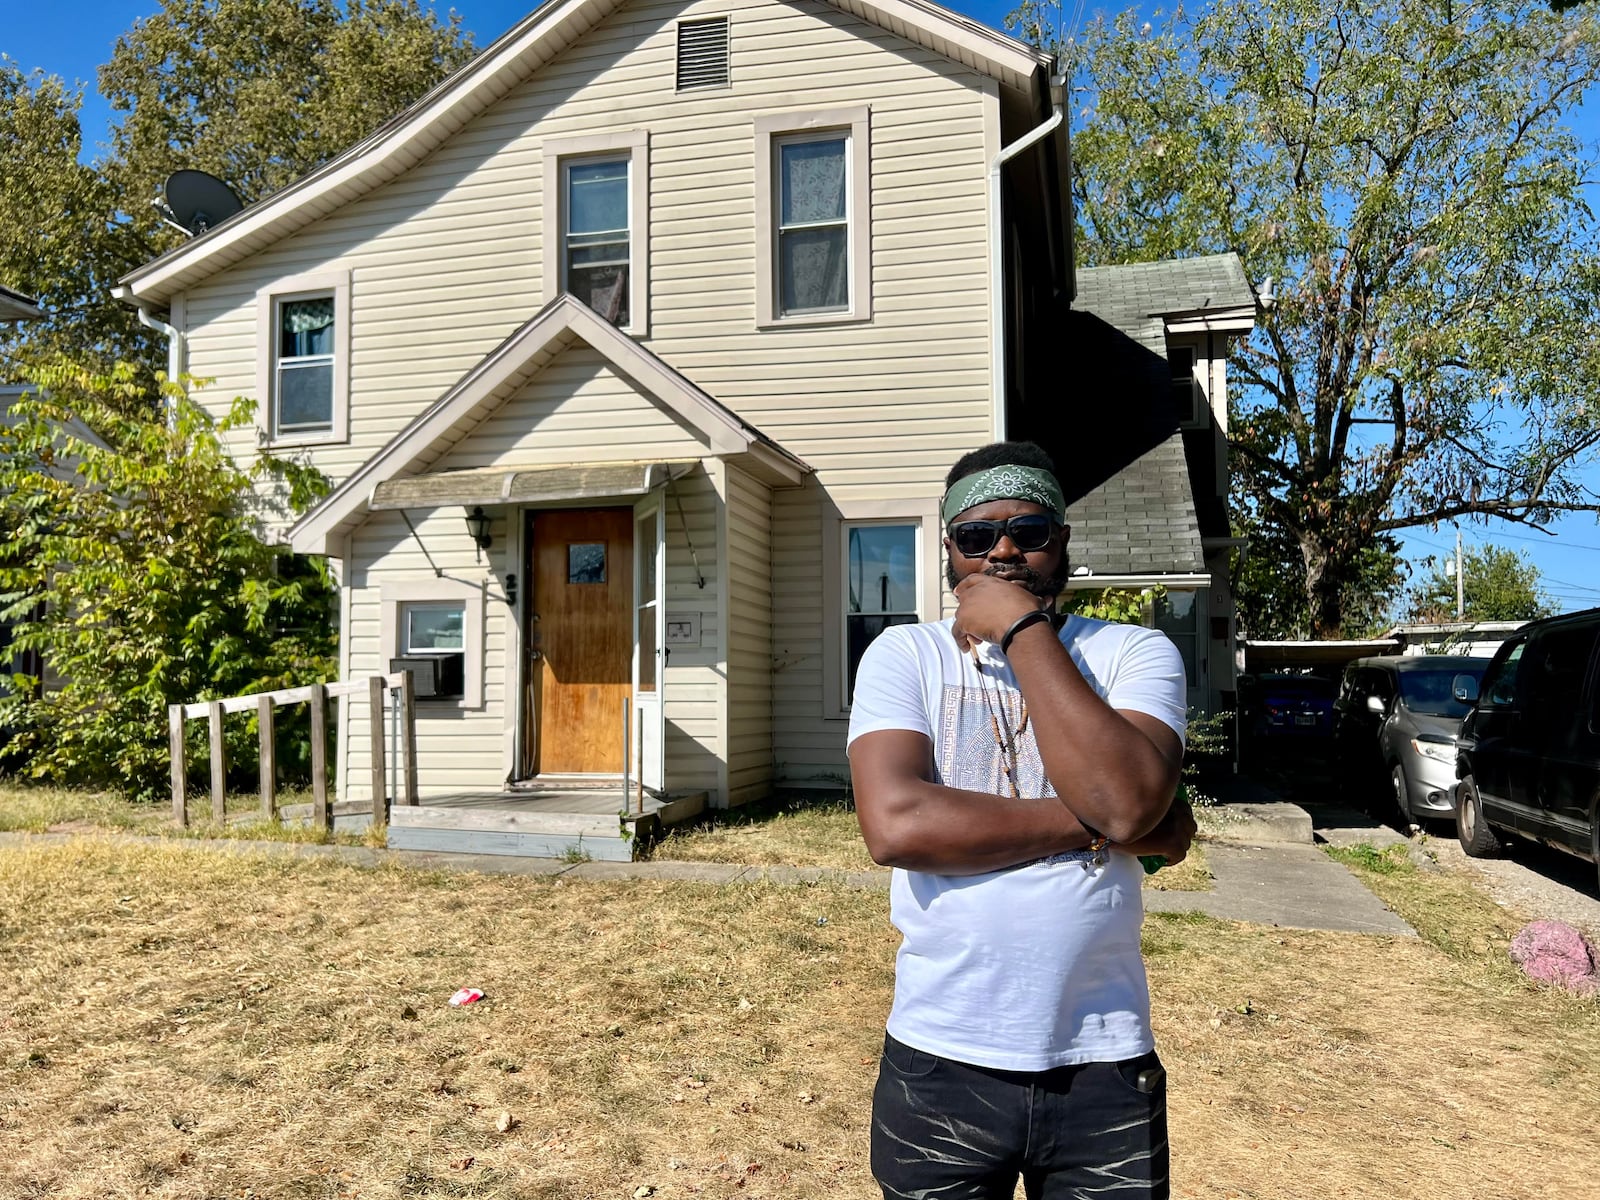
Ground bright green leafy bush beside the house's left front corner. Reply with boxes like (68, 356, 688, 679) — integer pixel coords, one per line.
(0, 363, 338, 798)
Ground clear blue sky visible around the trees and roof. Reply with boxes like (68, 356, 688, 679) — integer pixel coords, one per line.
(9, 0, 1600, 610)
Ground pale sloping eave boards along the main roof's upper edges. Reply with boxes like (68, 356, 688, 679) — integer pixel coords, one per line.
(112, 0, 1053, 304)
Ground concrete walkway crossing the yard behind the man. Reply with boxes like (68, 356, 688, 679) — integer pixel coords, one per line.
(0, 822, 1414, 936)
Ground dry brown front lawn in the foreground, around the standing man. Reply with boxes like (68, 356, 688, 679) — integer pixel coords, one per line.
(0, 840, 1600, 1200)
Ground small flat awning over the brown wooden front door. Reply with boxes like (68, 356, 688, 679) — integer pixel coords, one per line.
(377, 459, 699, 512)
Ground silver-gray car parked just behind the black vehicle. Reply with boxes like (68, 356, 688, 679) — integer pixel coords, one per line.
(1333, 654, 1490, 826)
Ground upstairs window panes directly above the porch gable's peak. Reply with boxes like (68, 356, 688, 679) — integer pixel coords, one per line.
(562, 157, 632, 325)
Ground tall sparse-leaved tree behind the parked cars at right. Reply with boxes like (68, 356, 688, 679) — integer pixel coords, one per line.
(1013, 0, 1600, 637)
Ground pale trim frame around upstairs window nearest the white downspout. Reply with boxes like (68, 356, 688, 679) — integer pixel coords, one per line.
(755, 106, 872, 328)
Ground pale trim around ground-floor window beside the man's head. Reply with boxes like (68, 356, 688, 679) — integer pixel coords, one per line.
(822, 498, 944, 720)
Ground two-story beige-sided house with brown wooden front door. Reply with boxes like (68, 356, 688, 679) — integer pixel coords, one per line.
(117, 0, 1248, 805)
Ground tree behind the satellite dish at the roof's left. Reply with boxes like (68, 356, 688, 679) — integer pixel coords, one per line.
(0, 0, 475, 380)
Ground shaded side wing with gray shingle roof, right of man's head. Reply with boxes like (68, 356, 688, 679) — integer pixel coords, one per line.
(1035, 254, 1256, 712)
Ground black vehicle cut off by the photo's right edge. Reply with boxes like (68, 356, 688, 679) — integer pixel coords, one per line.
(1456, 608, 1600, 896)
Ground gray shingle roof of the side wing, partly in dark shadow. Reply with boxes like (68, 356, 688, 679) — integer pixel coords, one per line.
(1038, 254, 1256, 576)
